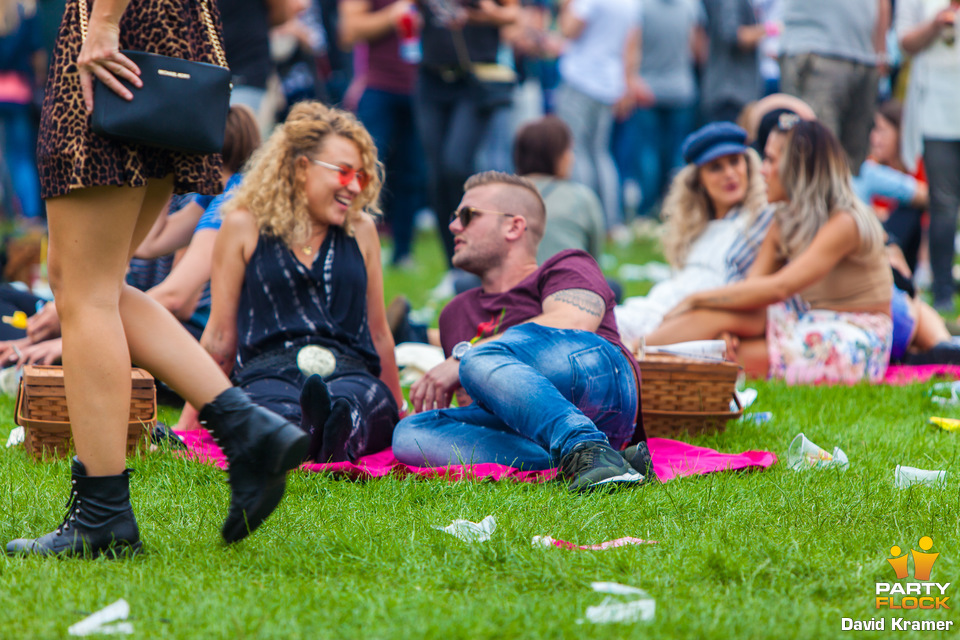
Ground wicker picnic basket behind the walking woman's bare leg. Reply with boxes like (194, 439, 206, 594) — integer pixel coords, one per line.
(15, 365, 157, 460)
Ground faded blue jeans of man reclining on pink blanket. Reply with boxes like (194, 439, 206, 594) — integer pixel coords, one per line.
(393, 323, 638, 470)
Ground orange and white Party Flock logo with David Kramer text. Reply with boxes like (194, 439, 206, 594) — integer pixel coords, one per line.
(841, 536, 953, 631)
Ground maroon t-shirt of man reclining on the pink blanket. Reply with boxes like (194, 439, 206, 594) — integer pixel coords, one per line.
(440, 249, 640, 392)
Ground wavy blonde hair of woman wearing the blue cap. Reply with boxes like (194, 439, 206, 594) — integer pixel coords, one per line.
(660, 149, 767, 269)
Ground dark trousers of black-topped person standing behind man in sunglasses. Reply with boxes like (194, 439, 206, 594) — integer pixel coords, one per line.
(416, 72, 492, 262)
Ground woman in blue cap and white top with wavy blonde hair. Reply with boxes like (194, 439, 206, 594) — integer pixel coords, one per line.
(615, 122, 773, 344)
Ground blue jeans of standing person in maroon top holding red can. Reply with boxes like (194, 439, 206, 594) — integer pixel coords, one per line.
(357, 89, 427, 264)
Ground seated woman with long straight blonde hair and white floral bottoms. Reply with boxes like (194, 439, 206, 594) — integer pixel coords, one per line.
(647, 115, 893, 383)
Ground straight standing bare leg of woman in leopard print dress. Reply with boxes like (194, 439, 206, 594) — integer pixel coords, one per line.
(47, 187, 147, 476)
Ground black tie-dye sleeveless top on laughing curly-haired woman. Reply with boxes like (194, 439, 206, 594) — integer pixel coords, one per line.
(237, 227, 380, 376)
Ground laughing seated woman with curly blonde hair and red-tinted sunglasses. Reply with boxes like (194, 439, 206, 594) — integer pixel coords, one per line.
(201, 102, 403, 462)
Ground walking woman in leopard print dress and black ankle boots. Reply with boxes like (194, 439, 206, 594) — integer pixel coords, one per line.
(7, 0, 309, 556)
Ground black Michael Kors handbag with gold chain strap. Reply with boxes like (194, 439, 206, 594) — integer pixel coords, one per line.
(79, 0, 231, 153)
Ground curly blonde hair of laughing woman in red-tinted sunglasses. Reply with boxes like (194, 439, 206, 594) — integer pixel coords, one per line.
(224, 101, 383, 248)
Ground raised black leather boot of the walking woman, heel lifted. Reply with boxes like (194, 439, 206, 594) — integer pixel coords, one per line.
(199, 387, 310, 542)
